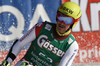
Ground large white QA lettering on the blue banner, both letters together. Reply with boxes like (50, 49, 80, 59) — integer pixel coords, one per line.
(0, 4, 51, 41)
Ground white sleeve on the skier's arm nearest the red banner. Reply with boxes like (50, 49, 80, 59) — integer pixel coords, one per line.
(59, 41, 79, 66)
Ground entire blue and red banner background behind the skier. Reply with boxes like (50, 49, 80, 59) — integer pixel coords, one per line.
(0, 0, 100, 66)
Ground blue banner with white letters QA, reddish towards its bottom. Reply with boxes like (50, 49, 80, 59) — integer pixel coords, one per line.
(0, 0, 61, 65)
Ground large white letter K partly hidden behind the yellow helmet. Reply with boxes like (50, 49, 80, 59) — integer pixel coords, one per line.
(72, 0, 91, 31)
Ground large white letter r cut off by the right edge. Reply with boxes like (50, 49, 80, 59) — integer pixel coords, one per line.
(90, 3, 100, 31)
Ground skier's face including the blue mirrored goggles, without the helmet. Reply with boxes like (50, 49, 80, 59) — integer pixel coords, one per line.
(56, 12, 74, 34)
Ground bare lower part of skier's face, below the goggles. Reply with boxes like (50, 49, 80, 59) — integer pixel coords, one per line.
(56, 20, 70, 34)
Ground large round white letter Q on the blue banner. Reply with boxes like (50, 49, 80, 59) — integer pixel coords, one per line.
(0, 5, 25, 41)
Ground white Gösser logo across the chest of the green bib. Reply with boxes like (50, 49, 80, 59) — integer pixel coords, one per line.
(37, 35, 65, 57)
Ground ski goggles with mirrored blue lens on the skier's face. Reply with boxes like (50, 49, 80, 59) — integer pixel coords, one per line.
(57, 12, 74, 25)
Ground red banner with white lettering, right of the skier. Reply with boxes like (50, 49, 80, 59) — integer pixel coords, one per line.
(63, 0, 100, 63)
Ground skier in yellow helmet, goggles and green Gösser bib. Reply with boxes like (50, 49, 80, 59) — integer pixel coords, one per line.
(0, 2, 81, 66)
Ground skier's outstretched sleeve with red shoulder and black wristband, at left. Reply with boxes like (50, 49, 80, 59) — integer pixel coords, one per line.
(6, 22, 44, 63)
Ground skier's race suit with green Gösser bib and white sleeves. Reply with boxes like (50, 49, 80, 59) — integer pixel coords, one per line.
(6, 22, 78, 66)
